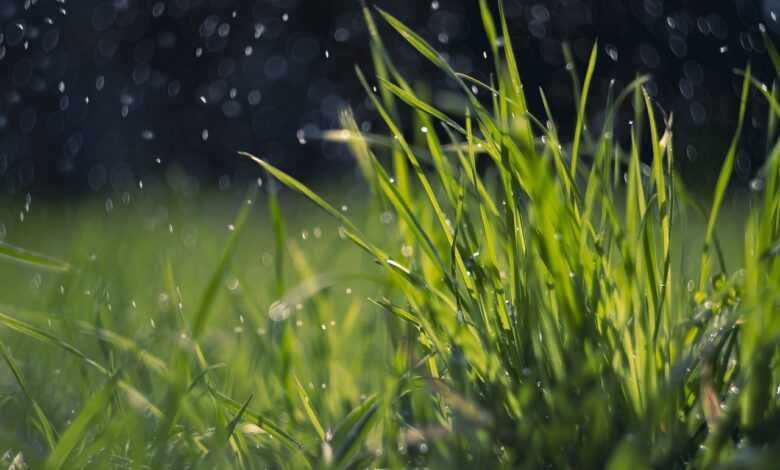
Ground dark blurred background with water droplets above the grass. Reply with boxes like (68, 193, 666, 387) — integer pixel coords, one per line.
(0, 0, 780, 196)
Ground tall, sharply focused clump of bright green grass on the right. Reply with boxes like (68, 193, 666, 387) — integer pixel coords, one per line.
(250, 0, 780, 468)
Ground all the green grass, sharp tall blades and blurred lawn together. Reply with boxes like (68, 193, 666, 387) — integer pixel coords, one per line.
(0, 0, 780, 469)
